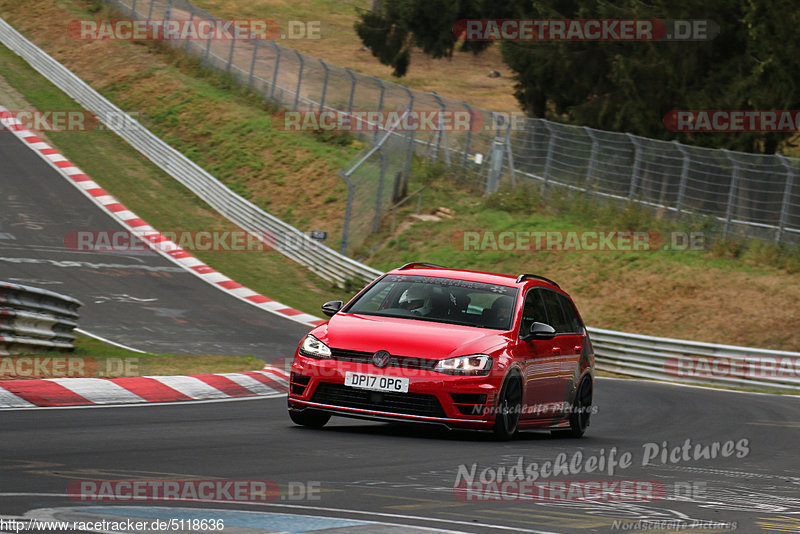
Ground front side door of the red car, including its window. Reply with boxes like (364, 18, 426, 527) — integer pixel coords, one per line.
(515, 287, 563, 419)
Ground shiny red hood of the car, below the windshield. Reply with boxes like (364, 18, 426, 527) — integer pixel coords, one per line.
(312, 313, 508, 359)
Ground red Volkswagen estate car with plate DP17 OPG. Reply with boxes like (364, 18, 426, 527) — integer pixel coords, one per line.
(288, 263, 594, 439)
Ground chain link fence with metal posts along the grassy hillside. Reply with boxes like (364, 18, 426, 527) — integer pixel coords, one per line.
(104, 0, 800, 253)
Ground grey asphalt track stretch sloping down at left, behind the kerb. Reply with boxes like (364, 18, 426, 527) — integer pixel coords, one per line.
(0, 131, 310, 360)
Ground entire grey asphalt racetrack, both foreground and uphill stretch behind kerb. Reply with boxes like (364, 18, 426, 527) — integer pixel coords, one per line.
(0, 119, 800, 534)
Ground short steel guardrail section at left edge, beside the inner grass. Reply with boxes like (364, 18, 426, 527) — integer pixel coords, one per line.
(0, 282, 82, 355)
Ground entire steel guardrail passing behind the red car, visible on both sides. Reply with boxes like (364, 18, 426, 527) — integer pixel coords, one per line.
(0, 19, 800, 391)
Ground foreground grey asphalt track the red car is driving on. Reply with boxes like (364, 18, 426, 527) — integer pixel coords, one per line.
(0, 379, 800, 533)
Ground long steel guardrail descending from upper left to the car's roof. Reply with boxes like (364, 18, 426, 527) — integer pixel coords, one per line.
(0, 19, 380, 285)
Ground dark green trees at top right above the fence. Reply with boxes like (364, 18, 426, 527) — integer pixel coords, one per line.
(356, 0, 800, 153)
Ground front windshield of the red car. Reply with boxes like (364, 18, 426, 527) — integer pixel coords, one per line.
(344, 274, 518, 330)
